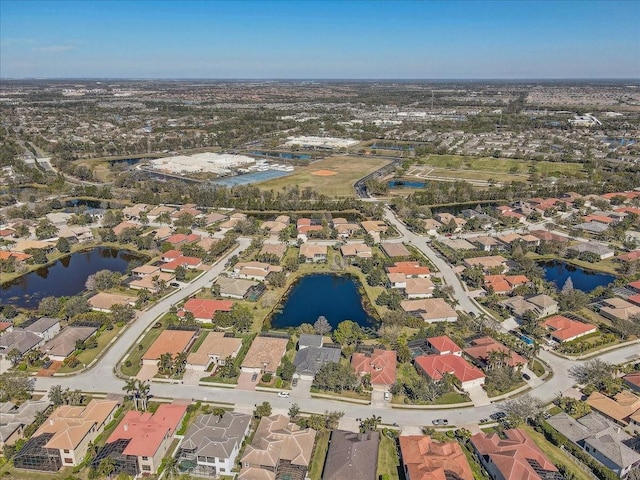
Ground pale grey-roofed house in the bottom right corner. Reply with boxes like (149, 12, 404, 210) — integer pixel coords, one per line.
(547, 412, 640, 478)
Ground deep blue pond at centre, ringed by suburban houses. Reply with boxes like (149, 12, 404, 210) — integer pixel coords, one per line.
(271, 274, 372, 328)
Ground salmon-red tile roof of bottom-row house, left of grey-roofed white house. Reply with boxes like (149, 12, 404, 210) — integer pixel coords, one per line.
(107, 404, 187, 457)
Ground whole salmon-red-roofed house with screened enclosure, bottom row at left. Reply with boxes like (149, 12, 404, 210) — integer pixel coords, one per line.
(93, 404, 187, 476)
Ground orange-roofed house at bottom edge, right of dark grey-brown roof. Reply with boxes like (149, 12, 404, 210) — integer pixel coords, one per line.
(398, 435, 473, 480)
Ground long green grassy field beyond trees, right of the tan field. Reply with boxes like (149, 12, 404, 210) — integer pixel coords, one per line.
(416, 155, 584, 181)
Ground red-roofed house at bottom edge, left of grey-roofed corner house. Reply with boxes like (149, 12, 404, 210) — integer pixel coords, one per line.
(471, 428, 558, 480)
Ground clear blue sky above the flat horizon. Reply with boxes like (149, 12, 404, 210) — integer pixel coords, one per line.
(0, 0, 640, 79)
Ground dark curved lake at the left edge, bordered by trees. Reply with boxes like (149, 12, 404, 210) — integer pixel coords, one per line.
(0, 247, 139, 308)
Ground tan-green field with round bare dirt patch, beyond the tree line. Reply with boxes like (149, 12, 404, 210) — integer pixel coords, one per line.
(256, 156, 389, 197)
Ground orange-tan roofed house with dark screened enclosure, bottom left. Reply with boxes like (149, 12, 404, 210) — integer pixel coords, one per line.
(13, 398, 120, 472)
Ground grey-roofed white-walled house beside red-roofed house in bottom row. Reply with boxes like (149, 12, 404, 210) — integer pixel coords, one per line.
(177, 412, 251, 477)
